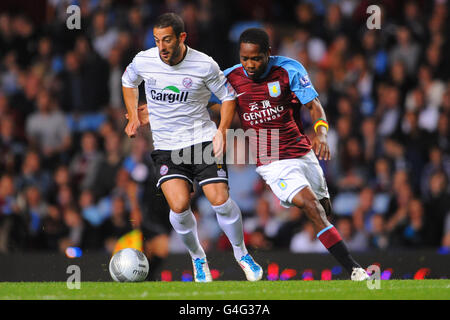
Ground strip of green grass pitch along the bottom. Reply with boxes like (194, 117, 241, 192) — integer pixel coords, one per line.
(0, 280, 450, 300)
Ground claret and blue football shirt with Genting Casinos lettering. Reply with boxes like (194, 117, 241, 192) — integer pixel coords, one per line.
(224, 56, 318, 165)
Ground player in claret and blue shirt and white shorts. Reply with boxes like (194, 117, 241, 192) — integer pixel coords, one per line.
(224, 28, 369, 281)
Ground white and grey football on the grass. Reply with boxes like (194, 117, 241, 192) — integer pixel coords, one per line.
(109, 248, 148, 282)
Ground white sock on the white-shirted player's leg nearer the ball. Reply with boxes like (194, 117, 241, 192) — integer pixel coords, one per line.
(169, 208, 206, 260)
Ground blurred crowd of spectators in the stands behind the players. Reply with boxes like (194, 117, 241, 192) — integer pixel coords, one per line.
(0, 0, 450, 252)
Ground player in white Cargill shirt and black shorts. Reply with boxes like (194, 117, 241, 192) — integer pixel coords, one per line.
(122, 13, 263, 282)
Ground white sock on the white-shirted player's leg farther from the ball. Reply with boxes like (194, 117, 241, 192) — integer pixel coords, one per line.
(212, 198, 248, 261)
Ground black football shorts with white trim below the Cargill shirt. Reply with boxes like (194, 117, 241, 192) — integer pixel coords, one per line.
(152, 141, 228, 188)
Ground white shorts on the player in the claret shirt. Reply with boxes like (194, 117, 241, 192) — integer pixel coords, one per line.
(256, 150, 330, 208)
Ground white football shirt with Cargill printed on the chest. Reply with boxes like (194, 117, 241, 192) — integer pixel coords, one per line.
(122, 46, 236, 150)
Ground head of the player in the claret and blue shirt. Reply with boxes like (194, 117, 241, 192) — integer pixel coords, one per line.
(239, 28, 270, 79)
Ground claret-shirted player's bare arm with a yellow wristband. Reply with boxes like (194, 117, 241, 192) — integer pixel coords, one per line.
(305, 97, 331, 160)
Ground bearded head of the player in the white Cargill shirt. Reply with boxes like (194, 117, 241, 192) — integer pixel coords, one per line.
(153, 13, 186, 65)
